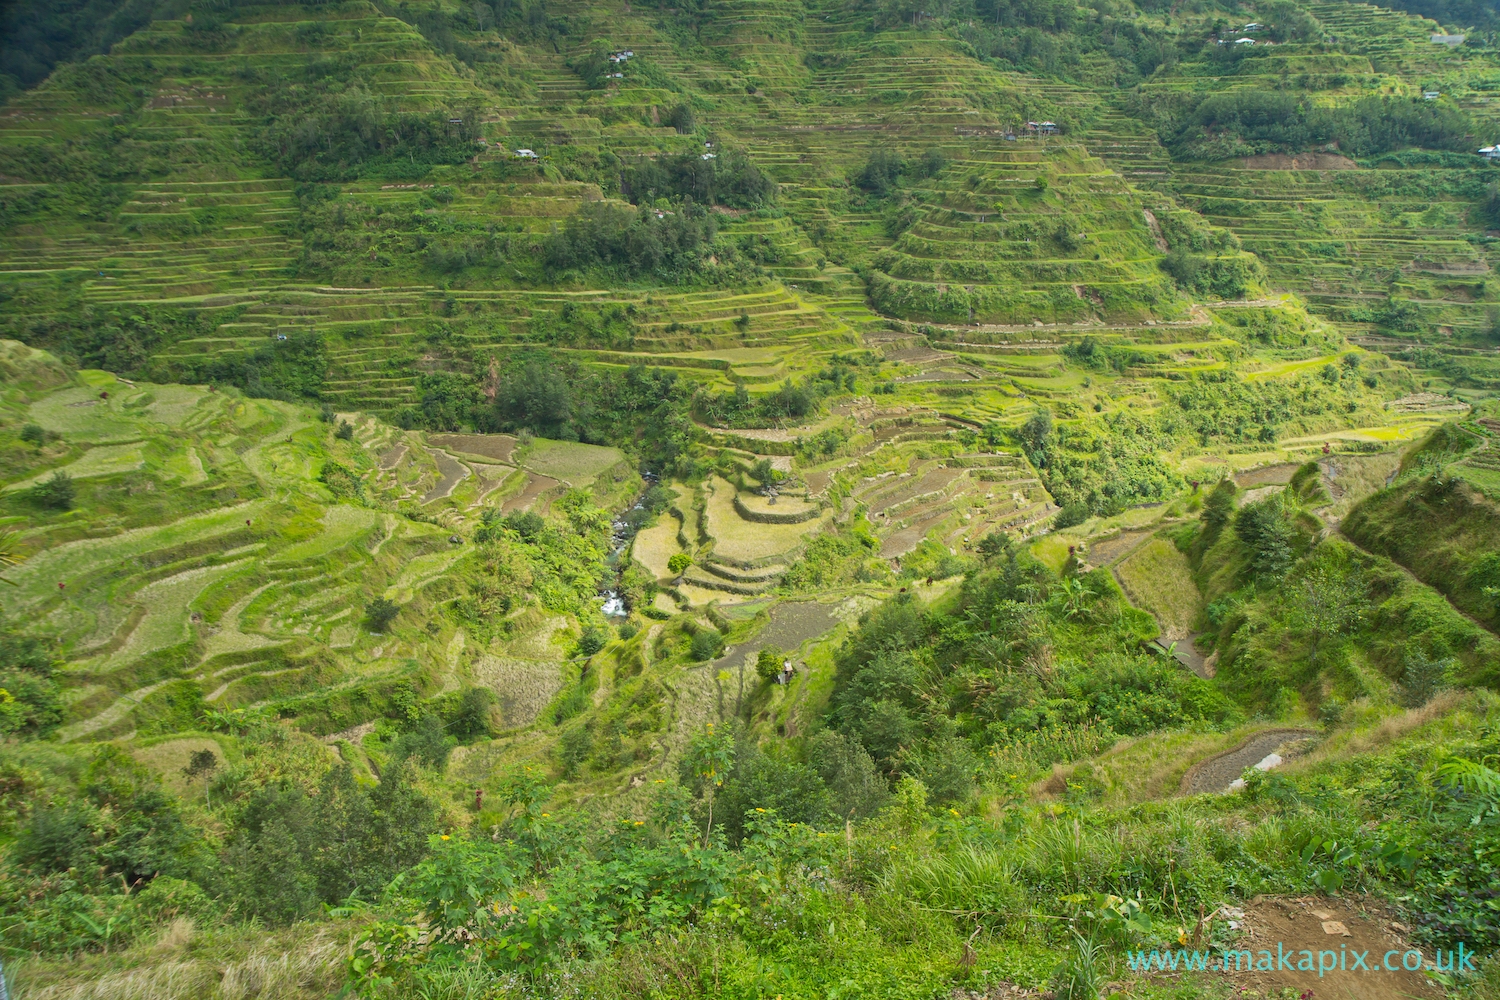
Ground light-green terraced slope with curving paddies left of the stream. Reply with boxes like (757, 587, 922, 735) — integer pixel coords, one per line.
(6, 343, 638, 741)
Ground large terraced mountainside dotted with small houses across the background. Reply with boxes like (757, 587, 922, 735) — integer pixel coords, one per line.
(0, 1, 1500, 641)
